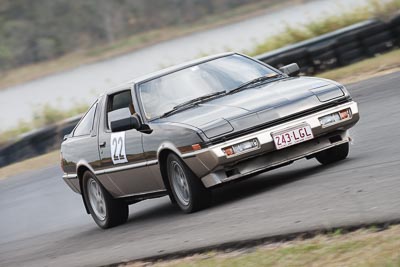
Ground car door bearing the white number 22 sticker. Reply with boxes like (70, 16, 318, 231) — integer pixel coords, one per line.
(99, 89, 162, 196)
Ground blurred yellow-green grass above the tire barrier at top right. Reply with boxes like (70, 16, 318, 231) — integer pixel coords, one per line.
(247, 0, 400, 56)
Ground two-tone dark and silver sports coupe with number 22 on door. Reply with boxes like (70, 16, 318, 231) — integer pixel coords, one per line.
(61, 53, 359, 228)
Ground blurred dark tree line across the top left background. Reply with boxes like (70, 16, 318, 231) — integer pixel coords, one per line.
(0, 0, 258, 70)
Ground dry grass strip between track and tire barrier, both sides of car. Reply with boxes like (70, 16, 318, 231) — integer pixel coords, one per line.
(0, 49, 400, 179)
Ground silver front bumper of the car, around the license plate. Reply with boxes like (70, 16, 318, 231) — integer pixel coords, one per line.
(183, 102, 359, 187)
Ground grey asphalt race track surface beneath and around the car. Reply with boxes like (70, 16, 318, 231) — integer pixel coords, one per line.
(0, 73, 400, 266)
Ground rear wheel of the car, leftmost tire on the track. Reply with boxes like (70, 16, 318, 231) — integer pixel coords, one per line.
(82, 171, 129, 229)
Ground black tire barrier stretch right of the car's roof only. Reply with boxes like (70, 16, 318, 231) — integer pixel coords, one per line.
(256, 15, 400, 75)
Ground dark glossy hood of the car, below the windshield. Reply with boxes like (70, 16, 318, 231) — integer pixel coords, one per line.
(158, 77, 345, 139)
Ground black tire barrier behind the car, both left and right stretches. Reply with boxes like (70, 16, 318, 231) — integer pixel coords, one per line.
(0, 15, 400, 167)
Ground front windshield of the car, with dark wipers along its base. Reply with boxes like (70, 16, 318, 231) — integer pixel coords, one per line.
(139, 54, 276, 119)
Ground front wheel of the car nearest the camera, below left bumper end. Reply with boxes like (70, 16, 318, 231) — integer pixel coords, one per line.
(167, 153, 212, 213)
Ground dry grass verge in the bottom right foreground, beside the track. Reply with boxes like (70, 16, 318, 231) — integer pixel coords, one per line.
(127, 225, 400, 267)
